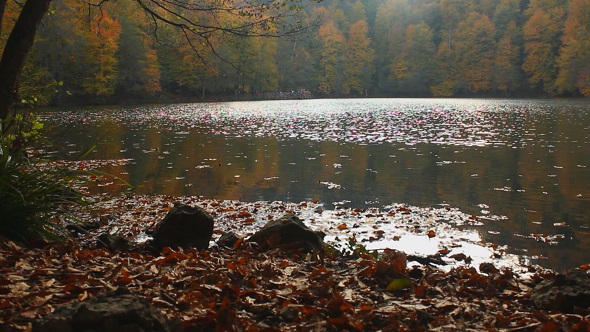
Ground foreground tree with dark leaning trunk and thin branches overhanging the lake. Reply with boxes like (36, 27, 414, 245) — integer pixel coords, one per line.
(0, 0, 324, 119)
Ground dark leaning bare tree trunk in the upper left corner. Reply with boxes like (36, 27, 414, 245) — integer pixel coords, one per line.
(0, 0, 51, 120)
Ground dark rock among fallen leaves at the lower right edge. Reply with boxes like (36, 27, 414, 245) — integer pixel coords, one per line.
(531, 269, 590, 313)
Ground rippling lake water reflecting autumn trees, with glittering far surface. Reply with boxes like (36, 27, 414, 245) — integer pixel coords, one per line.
(45, 99, 590, 270)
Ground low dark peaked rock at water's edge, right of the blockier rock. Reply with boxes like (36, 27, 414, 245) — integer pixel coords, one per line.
(248, 214, 324, 251)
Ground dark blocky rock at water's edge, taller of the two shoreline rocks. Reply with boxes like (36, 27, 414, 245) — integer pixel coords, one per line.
(152, 203, 213, 250)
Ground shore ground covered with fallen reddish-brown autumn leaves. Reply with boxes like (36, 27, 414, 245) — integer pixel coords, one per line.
(0, 192, 590, 331)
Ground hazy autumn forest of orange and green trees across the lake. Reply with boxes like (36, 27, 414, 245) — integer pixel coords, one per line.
(1, 0, 590, 106)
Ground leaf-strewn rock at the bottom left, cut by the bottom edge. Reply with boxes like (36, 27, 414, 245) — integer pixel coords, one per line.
(32, 292, 182, 332)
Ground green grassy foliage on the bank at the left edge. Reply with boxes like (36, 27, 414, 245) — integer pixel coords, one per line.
(0, 114, 83, 242)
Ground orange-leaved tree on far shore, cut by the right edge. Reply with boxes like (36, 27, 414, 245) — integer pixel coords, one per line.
(556, 0, 590, 96)
